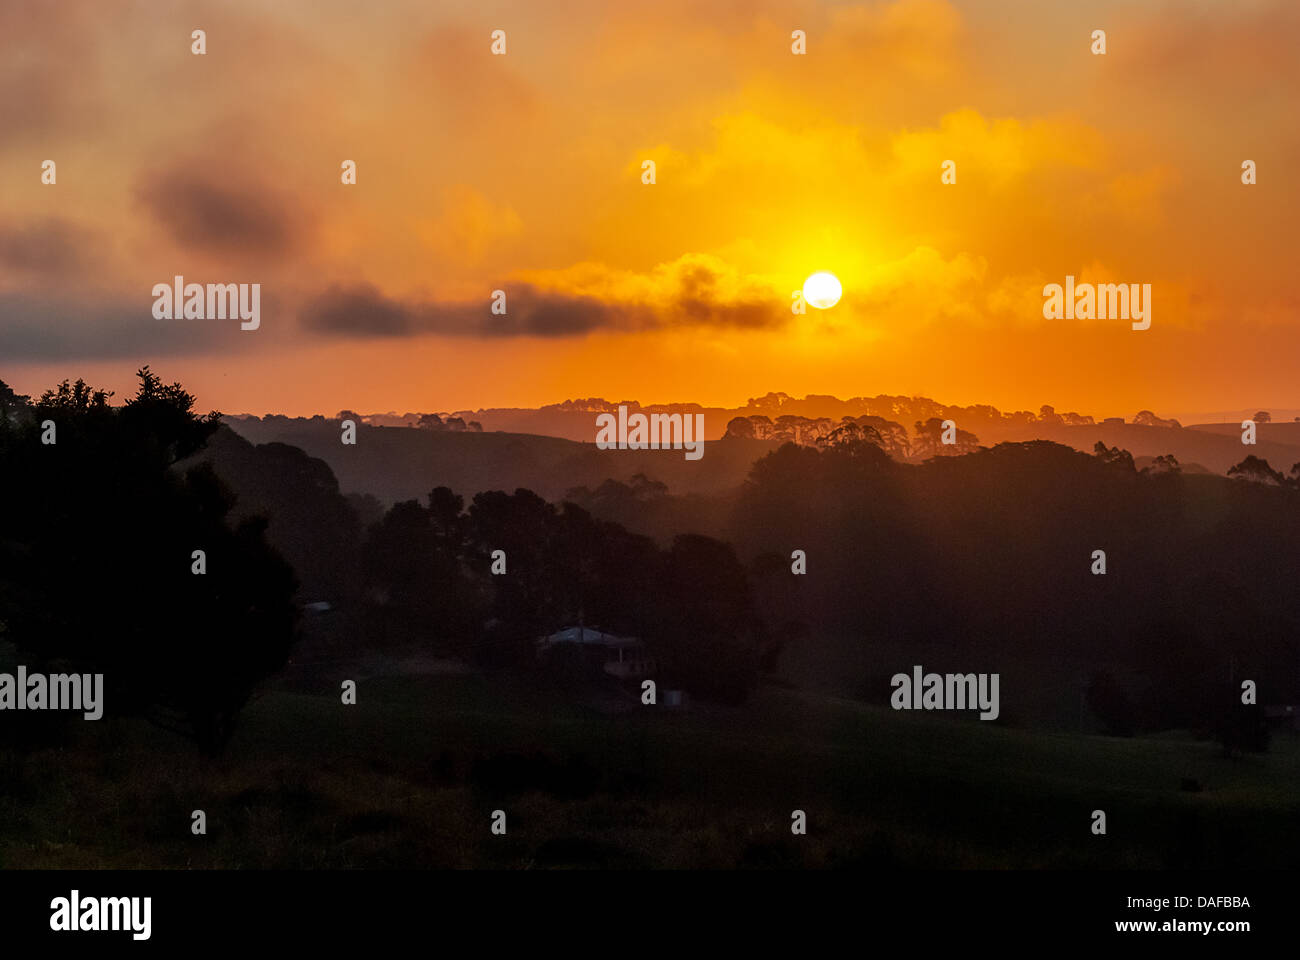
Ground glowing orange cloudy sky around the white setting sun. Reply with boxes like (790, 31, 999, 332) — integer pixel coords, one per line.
(0, 0, 1300, 416)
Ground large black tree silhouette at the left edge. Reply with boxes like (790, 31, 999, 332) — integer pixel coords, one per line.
(0, 367, 295, 753)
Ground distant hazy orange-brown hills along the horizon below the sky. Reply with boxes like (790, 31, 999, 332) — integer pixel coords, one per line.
(226, 393, 1300, 503)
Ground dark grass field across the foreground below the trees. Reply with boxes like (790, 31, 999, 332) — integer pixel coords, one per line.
(0, 675, 1300, 869)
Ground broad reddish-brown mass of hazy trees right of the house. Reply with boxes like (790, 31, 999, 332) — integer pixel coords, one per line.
(727, 441, 1300, 732)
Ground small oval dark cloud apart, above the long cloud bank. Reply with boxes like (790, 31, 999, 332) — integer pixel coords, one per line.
(137, 164, 303, 256)
